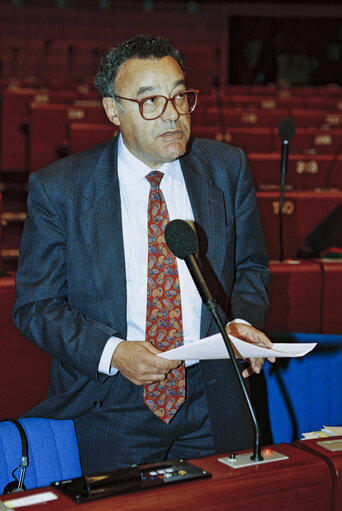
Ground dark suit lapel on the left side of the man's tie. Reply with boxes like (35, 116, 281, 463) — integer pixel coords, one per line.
(80, 140, 127, 338)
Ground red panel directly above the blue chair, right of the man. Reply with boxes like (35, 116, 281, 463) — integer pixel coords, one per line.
(265, 259, 342, 336)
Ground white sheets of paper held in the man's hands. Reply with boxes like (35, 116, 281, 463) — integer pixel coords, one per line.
(158, 334, 317, 360)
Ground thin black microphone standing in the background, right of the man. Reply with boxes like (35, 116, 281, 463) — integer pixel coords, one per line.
(278, 117, 296, 261)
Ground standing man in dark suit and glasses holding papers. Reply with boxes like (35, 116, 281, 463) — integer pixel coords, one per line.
(13, 36, 271, 473)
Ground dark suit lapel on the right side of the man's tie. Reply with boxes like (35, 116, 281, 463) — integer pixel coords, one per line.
(181, 144, 226, 337)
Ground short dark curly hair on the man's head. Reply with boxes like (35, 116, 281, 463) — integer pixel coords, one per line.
(95, 34, 185, 98)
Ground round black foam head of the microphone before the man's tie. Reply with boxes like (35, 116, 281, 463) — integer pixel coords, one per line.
(164, 220, 198, 259)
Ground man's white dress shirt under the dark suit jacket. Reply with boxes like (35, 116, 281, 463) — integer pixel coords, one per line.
(99, 135, 202, 375)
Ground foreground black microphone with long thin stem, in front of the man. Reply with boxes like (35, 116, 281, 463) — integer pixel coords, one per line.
(164, 220, 263, 461)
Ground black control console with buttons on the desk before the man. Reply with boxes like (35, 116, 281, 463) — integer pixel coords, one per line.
(51, 460, 211, 503)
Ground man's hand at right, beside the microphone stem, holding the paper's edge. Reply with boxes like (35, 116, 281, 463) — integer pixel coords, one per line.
(226, 323, 275, 378)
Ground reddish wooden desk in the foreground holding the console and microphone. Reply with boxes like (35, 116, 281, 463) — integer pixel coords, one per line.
(1, 444, 332, 511)
